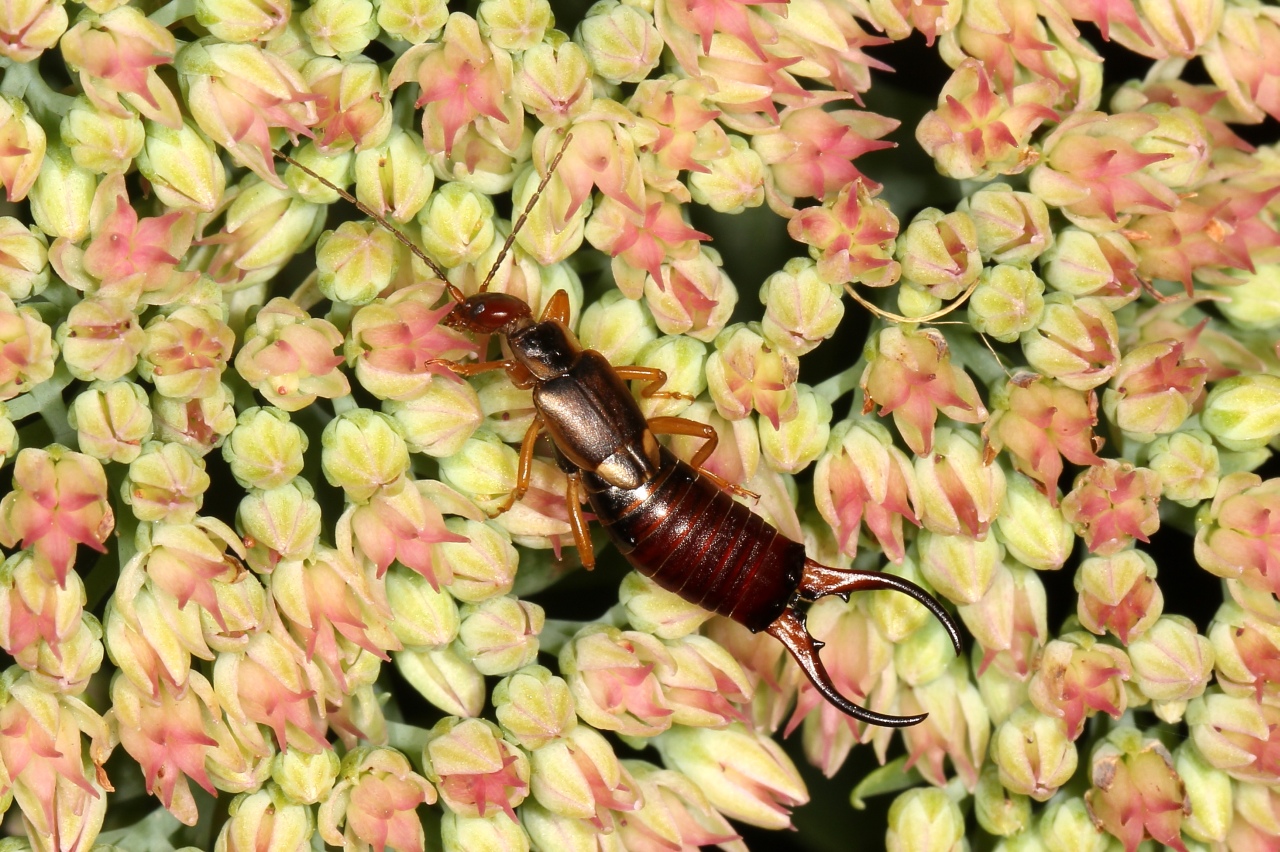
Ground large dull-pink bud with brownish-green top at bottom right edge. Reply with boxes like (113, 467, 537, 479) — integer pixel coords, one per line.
(1084, 728, 1190, 849)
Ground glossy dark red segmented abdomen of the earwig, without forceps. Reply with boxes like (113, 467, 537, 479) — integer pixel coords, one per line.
(582, 449, 805, 632)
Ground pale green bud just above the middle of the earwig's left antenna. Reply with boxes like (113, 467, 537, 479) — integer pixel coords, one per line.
(355, 126, 443, 225)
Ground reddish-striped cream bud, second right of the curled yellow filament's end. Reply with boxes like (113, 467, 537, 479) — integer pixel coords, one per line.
(1023, 293, 1120, 390)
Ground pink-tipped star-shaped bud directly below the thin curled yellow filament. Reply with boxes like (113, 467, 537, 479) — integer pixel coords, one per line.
(861, 326, 987, 455)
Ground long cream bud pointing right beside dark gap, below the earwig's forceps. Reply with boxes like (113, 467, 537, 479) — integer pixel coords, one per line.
(655, 724, 809, 829)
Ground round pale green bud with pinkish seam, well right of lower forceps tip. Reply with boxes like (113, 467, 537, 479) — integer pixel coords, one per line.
(989, 706, 1079, 802)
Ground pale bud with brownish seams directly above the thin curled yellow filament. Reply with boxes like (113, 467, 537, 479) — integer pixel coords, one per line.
(895, 207, 982, 301)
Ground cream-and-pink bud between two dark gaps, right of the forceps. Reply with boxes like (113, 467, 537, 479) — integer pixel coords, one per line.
(1075, 549, 1165, 645)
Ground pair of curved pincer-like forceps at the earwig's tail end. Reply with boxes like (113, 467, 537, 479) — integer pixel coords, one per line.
(768, 559, 961, 728)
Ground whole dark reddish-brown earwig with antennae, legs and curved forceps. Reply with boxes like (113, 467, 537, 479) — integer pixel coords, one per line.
(276, 136, 961, 727)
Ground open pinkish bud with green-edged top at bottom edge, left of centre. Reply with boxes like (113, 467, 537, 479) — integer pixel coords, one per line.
(316, 746, 435, 852)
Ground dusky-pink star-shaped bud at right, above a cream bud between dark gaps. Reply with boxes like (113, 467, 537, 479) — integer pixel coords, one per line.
(1062, 459, 1160, 555)
